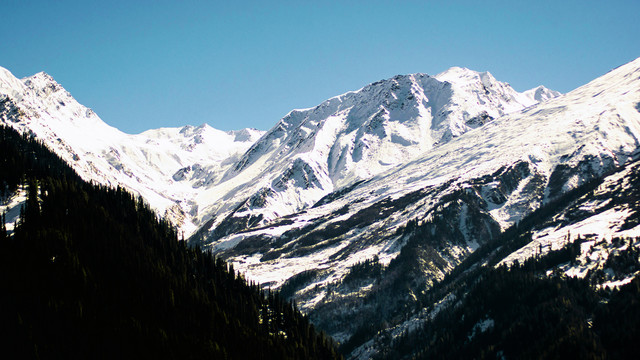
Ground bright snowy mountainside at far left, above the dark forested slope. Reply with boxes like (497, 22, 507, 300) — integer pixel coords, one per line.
(0, 68, 263, 236)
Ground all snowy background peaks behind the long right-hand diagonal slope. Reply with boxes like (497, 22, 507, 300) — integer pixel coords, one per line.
(0, 68, 559, 240)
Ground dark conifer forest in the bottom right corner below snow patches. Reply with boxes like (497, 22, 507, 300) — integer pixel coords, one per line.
(379, 241, 640, 359)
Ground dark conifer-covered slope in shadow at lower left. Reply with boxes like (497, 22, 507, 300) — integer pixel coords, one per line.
(0, 127, 339, 359)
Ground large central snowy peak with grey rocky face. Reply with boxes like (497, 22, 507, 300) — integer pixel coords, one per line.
(196, 68, 559, 238)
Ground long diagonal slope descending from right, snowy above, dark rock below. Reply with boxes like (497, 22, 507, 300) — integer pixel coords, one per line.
(199, 59, 640, 342)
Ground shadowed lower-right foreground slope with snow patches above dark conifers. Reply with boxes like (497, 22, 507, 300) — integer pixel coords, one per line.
(352, 154, 640, 359)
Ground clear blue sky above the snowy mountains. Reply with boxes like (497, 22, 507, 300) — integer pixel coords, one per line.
(0, 0, 640, 133)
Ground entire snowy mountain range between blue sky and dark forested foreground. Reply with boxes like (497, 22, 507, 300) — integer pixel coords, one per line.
(0, 59, 640, 358)
